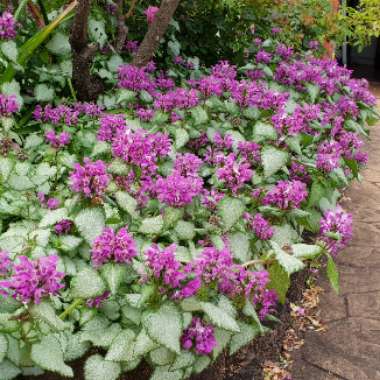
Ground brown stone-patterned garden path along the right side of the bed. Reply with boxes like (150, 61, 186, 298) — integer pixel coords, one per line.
(293, 85, 380, 380)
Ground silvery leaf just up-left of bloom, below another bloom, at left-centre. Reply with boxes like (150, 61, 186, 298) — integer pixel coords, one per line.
(74, 208, 104, 244)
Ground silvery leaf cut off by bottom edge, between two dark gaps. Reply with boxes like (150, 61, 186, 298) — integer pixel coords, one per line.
(84, 354, 121, 380)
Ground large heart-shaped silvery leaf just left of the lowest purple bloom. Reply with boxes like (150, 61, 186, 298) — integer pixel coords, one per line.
(143, 305, 182, 353)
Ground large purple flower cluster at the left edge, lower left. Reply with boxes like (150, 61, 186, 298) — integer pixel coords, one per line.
(0, 256, 64, 304)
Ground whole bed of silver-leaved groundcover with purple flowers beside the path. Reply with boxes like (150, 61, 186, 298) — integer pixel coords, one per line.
(0, 11, 376, 380)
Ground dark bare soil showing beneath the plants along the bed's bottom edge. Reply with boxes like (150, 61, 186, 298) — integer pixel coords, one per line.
(17, 271, 307, 380)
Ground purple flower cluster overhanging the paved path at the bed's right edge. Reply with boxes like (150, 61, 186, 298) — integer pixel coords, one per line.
(319, 207, 352, 255)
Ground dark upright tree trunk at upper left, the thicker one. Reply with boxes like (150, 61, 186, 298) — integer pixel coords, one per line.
(70, 0, 104, 101)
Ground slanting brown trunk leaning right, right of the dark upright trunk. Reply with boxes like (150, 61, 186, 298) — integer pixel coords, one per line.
(132, 0, 181, 67)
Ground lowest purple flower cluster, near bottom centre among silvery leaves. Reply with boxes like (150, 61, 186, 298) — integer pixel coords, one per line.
(181, 317, 217, 355)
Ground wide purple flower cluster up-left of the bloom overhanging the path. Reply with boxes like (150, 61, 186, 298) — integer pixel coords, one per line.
(263, 180, 308, 210)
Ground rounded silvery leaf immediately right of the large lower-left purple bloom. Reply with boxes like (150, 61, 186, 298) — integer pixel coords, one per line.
(71, 268, 106, 299)
